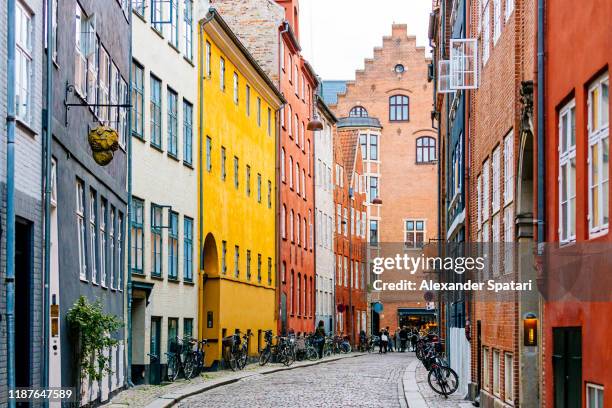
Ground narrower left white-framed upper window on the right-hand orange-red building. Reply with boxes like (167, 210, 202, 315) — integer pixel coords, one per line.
(559, 100, 576, 243)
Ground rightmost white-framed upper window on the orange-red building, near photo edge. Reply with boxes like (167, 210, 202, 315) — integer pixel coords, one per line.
(588, 73, 610, 234)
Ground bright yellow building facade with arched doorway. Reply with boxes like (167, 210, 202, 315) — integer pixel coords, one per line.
(198, 9, 284, 365)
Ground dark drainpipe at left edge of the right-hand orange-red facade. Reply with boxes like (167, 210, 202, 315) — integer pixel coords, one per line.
(537, 0, 546, 244)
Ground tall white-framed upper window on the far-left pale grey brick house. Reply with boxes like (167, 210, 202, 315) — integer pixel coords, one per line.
(14, 2, 32, 123)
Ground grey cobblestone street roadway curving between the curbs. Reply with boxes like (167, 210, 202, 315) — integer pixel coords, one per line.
(178, 353, 414, 408)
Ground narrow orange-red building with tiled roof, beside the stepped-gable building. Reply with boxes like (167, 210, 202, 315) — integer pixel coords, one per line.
(333, 129, 367, 345)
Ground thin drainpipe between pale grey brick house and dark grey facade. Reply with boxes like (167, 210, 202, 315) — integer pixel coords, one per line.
(41, 1, 55, 400)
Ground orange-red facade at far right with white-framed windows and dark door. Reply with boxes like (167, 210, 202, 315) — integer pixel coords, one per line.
(537, 0, 612, 407)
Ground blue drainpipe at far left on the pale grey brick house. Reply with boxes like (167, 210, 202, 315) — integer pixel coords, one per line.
(5, 0, 16, 408)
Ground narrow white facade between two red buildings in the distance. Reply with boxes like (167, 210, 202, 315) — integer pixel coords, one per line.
(314, 99, 336, 333)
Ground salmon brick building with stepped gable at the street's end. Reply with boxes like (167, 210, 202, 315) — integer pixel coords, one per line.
(322, 24, 438, 332)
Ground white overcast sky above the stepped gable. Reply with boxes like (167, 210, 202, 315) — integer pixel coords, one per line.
(300, 0, 431, 80)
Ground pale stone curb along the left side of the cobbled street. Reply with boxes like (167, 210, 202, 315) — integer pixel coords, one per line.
(145, 353, 364, 408)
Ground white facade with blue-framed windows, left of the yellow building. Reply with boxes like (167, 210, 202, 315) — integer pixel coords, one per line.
(130, 0, 201, 383)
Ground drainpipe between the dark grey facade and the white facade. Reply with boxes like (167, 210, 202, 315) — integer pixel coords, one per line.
(126, 1, 134, 387)
